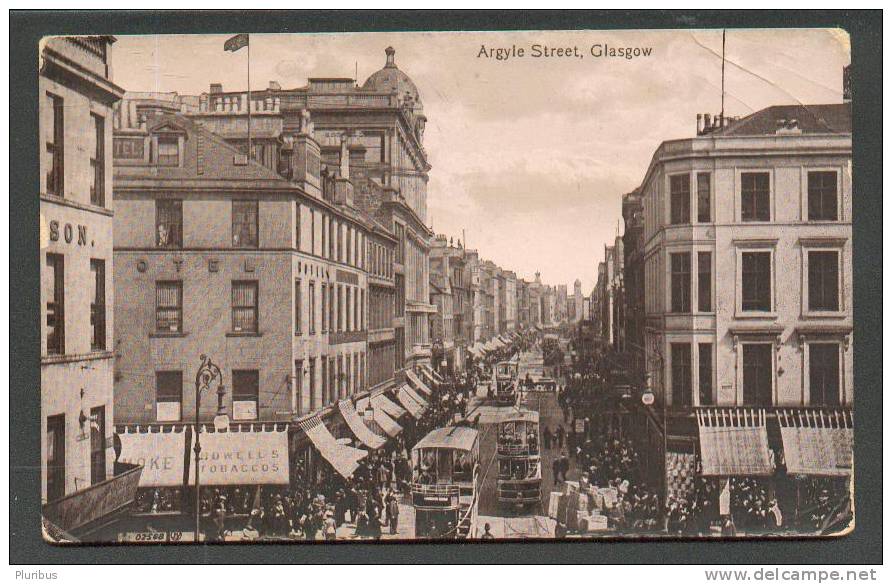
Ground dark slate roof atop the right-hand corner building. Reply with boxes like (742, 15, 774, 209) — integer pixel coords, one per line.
(713, 103, 852, 136)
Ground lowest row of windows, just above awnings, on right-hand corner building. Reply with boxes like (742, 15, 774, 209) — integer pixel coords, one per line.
(670, 342, 841, 407)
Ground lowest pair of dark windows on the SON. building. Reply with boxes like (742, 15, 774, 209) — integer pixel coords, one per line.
(46, 406, 107, 501)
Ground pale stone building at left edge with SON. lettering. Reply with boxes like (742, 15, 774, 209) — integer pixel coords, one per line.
(37, 36, 125, 512)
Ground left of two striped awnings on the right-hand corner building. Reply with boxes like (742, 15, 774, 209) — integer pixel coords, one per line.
(697, 408, 774, 477)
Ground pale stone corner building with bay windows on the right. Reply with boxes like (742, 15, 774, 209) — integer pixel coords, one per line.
(640, 103, 854, 496)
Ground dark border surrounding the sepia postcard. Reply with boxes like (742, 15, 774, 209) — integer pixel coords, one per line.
(9, 10, 883, 564)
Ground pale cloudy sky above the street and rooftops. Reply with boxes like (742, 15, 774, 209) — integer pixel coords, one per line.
(114, 30, 850, 294)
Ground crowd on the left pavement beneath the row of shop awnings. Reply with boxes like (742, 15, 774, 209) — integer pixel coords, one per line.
(134, 364, 484, 540)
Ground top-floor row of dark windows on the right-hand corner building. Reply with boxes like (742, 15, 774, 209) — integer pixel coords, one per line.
(669, 170, 839, 225)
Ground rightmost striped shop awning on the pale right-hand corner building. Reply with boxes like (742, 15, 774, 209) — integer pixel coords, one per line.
(777, 410, 854, 477)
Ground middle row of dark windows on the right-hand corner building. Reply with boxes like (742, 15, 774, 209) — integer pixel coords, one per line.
(669, 250, 840, 314)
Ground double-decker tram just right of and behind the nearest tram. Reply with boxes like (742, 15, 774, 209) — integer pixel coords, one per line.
(496, 409, 542, 508)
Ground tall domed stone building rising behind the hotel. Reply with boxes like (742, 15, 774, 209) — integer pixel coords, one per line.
(193, 47, 436, 370)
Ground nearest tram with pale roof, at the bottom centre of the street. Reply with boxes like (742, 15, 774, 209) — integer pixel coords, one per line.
(411, 426, 480, 539)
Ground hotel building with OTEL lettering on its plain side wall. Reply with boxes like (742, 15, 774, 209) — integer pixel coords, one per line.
(114, 107, 374, 424)
